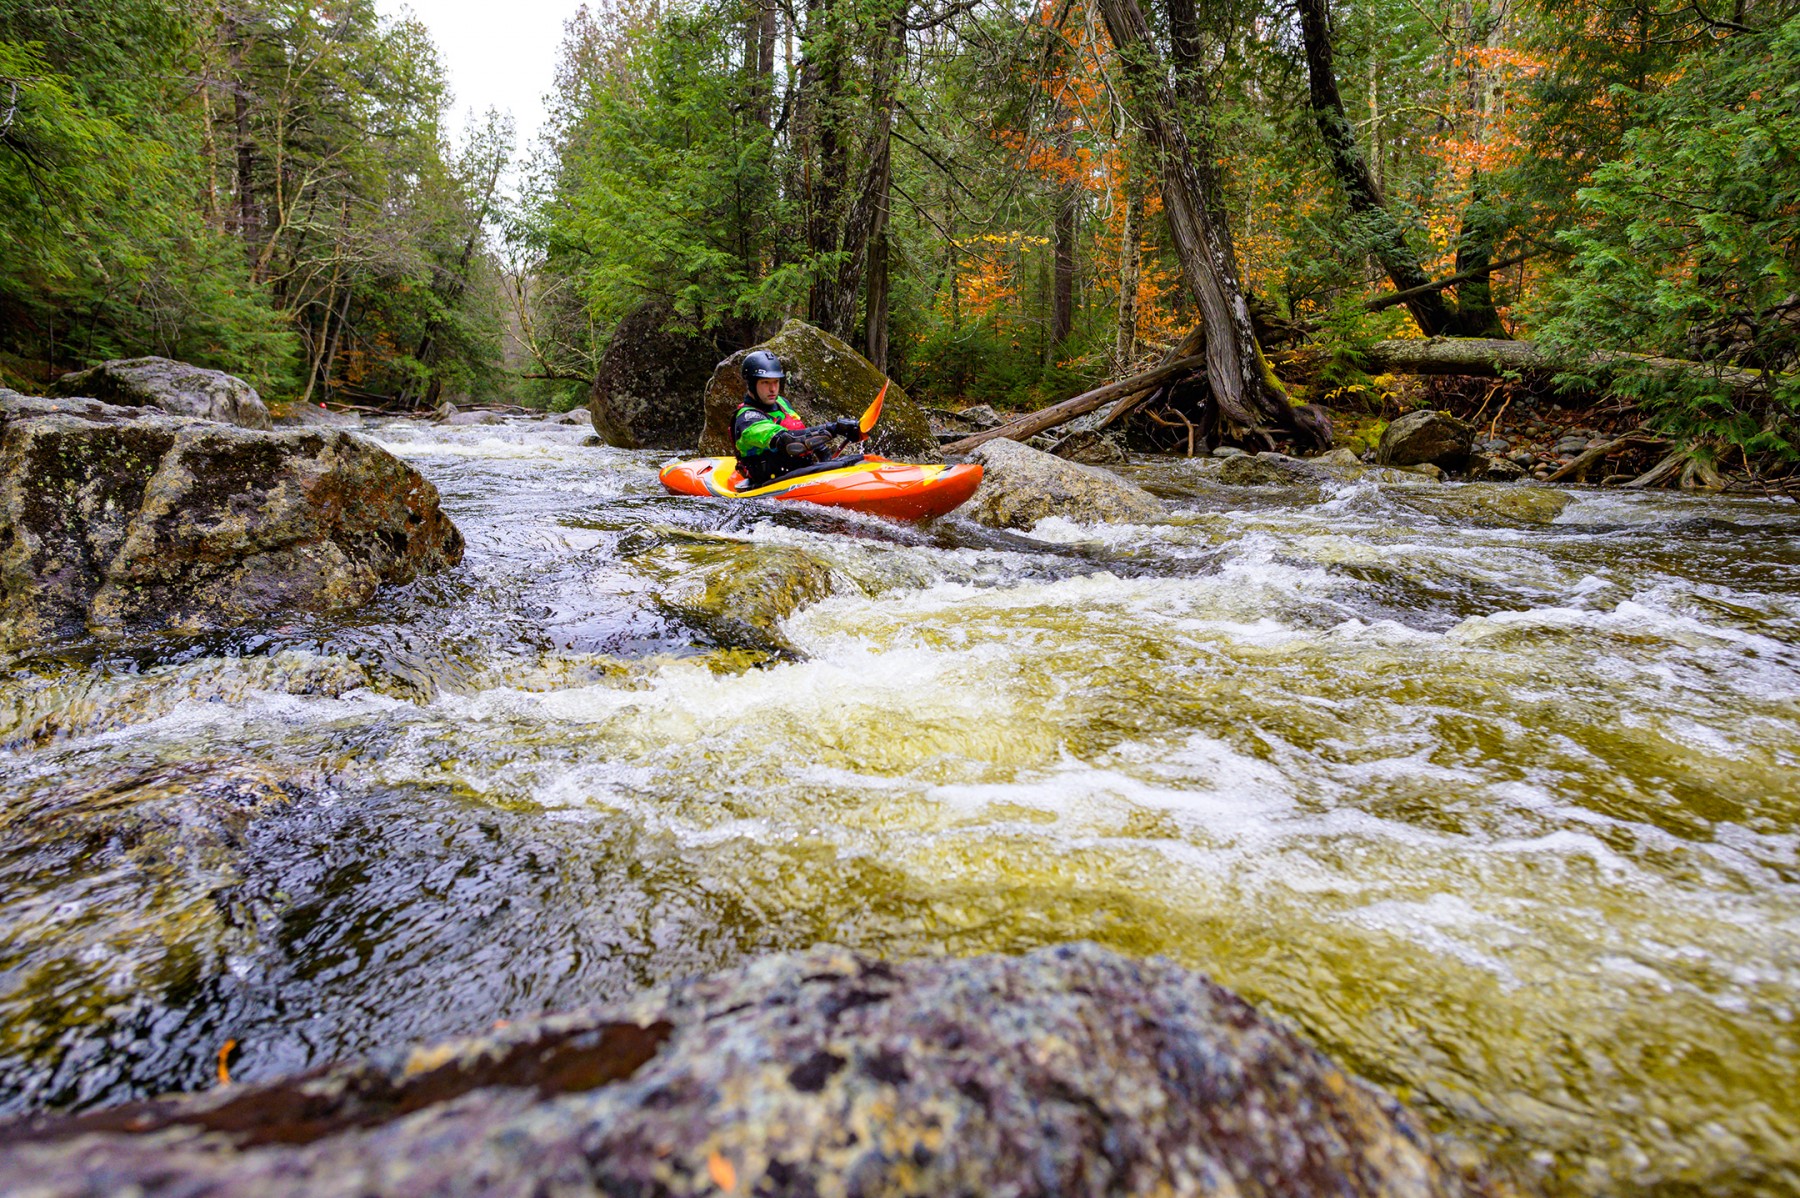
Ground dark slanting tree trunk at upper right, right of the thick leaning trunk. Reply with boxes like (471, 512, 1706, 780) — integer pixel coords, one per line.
(1300, 0, 1454, 336)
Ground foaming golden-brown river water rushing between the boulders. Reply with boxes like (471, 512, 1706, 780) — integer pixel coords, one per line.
(0, 421, 1800, 1194)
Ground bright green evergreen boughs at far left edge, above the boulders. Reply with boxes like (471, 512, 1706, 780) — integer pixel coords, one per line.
(0, 8, 293, 387)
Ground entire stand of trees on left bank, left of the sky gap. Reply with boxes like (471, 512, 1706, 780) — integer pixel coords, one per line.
(0, 0, 511, 398)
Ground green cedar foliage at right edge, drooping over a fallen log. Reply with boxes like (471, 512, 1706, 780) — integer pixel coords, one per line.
(1544, 18, 1800, 457)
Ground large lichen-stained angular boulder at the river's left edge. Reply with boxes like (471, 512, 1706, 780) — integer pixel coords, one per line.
(0, 392, 463, 644)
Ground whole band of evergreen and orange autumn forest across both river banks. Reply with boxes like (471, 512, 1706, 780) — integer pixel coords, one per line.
(0, 0, 1800, 462)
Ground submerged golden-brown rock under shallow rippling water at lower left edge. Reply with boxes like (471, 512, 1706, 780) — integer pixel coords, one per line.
(0, 761, 297, 1108)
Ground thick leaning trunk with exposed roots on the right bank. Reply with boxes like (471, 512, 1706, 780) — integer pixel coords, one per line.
(1100, 0, 1328, 444)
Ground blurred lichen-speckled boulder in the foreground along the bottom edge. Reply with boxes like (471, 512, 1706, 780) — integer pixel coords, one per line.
(0, 944, 1501, 1198)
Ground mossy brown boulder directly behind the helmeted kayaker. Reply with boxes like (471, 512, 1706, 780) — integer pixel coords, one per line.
(700, 320, 943, 462)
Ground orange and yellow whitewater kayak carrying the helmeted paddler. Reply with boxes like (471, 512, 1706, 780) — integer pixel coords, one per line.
(659, 455, 981, 520)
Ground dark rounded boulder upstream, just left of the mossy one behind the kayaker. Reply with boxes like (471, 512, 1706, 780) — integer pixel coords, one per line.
(587, 300, 725, 450)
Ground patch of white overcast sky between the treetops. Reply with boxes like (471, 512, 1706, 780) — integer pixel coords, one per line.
(380, 0, 581, 151)
